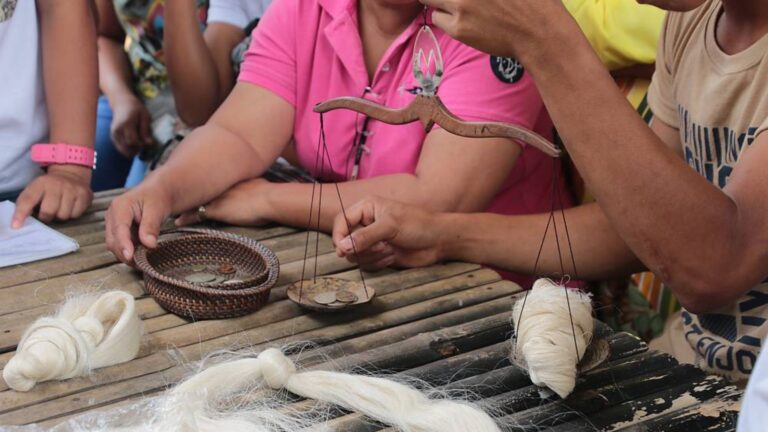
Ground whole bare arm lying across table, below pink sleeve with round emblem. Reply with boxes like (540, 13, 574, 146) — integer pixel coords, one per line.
(180, 129, 522, 231)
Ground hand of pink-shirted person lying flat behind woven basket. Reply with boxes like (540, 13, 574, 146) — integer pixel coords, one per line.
(176, 178, 271, 226)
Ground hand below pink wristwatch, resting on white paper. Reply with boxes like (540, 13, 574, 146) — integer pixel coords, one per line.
(11, 165, 93, 229)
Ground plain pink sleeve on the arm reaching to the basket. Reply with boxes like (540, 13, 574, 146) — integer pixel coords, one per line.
(238, 0, 302, 106)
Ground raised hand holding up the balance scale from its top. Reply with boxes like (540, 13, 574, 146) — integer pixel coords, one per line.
(420, 0, 573, 60)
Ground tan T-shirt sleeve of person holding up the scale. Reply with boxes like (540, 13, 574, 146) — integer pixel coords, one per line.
(648, 15, 680, 127)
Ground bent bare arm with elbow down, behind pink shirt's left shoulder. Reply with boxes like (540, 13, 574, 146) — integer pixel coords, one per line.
(164, 0, 245, 127)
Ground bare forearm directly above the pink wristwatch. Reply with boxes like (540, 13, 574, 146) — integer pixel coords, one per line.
(38, 0, 98, 148)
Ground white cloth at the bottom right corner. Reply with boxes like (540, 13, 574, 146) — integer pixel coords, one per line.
(736, 341, 768, 432)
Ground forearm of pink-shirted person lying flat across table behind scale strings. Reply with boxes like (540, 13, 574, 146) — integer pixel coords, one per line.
(264, 174, 484, 231)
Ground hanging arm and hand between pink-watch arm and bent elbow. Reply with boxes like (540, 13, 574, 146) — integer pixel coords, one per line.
(96, 0, 154, 157)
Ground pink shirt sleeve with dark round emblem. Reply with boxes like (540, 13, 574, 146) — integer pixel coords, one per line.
(438, 39, 544, 147)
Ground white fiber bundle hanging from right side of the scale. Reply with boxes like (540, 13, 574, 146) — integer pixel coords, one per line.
(512, 279, 594, 398)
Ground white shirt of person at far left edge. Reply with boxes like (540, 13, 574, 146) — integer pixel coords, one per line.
(0, 0, 48, 193)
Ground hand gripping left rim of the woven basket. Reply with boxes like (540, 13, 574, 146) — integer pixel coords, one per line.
(106, 182, 173, 264)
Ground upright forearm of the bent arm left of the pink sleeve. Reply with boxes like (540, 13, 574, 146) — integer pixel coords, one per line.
(164, 0, 220, 126)
